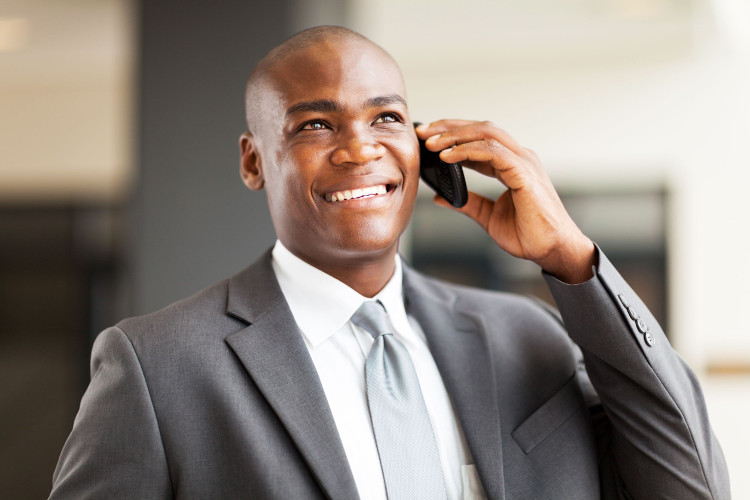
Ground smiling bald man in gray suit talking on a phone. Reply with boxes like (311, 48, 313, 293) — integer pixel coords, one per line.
(52, 27, 729, 499)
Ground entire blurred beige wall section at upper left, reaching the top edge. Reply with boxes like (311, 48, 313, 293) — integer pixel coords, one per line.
(0, 0, 135, 202)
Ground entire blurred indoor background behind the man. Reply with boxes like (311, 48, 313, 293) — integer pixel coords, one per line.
(0, 0, 750, 499)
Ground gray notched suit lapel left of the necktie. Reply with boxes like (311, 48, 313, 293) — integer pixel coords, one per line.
(227, 251, 358, 498)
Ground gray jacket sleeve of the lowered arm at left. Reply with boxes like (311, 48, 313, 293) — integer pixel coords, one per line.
(50, 327, 172, 499)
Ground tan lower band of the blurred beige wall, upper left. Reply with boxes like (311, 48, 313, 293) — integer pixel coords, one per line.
(0, 82, 131, 201)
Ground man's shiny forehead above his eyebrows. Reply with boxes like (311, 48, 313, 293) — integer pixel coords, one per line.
(268, 40, 406, 108)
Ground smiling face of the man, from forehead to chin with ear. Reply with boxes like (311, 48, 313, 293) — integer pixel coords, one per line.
(247, 40, 419, 269)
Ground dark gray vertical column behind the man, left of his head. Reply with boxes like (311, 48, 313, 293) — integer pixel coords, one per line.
(131, 0, 297, 313)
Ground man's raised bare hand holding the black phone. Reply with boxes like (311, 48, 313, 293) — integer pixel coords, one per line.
(416, 120, 596, 283)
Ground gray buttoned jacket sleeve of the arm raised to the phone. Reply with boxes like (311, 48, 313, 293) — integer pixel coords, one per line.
(544, 249, 730, 500)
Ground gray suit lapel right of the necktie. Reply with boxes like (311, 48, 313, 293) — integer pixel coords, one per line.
(404, 266, 505, 499)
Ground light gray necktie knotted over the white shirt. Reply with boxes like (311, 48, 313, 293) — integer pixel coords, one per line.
(352, 301, 446, 500)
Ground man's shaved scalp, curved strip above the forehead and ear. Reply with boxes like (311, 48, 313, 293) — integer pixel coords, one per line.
(245, 26, 400, 134)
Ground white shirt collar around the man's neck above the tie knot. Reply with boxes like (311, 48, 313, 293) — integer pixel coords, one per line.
(271, 240, 406, 347)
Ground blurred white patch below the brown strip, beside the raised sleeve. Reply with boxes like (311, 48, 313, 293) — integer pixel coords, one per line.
(701, 375, 750, 500)
